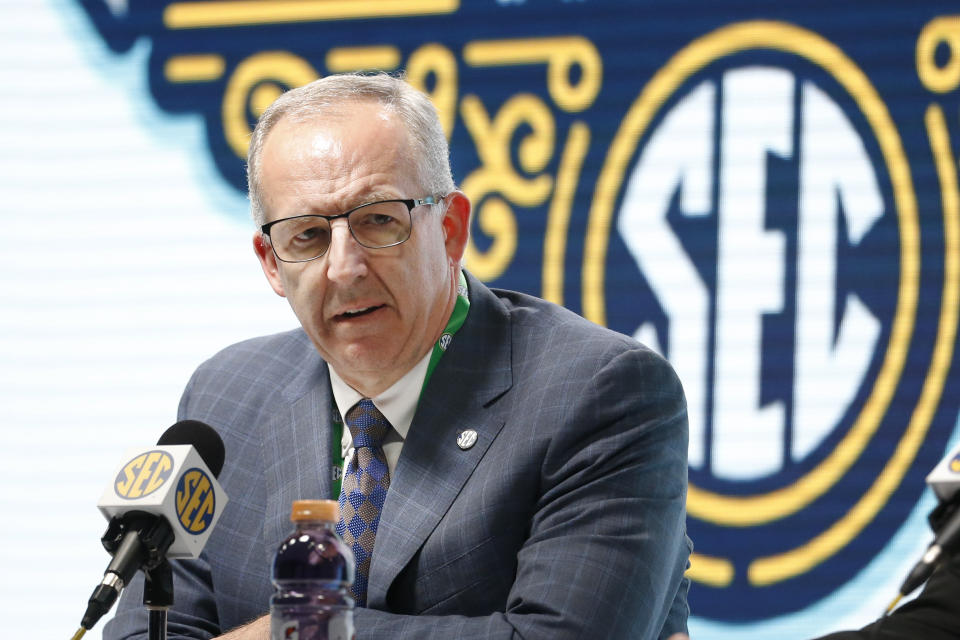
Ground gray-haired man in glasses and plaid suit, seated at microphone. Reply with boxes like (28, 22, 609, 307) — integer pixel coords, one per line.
(105, 75, 690, 640)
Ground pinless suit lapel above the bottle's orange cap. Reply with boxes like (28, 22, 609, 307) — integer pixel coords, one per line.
(262, 352, 340, 565)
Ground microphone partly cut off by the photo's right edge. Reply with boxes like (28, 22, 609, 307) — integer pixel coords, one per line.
(894, 444, 960, 604)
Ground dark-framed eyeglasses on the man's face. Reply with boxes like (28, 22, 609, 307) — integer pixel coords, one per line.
(260, 196, 440, 262)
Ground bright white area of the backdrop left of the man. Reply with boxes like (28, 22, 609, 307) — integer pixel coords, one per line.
(0, 0, 296, 639)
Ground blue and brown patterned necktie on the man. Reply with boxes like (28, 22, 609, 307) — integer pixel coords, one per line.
(337, 398, 391, 607)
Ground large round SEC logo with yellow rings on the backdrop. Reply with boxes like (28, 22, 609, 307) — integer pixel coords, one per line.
(583, 21, 958, 621)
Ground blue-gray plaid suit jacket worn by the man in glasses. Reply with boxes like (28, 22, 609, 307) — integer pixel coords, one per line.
(104, 278, 690, 640)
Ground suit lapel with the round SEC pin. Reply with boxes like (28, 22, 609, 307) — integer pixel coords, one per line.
(367, 276, 512, 609)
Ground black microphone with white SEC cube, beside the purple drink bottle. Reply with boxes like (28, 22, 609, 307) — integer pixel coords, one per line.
(80, 420, 227, 631)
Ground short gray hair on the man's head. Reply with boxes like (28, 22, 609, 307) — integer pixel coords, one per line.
(247, 73, 456, 227)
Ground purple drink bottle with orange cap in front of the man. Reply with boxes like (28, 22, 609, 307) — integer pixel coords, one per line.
(270, 500, 356, 640)
